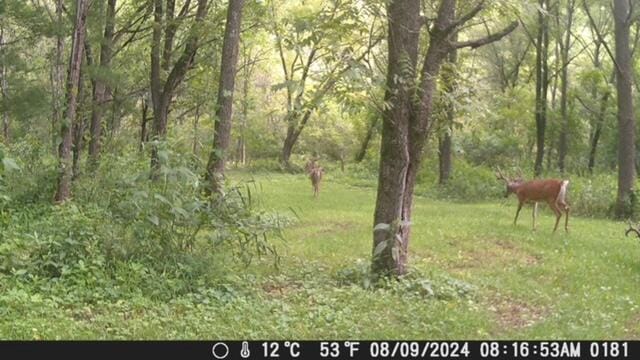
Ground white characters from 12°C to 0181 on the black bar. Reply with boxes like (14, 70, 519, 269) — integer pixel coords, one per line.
(246, 341, 637, 359)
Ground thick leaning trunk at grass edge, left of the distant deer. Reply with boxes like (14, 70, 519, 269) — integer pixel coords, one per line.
(207, 0, 244, 192)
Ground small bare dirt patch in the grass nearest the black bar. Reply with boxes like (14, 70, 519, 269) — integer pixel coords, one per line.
(487, 296, 548, 329)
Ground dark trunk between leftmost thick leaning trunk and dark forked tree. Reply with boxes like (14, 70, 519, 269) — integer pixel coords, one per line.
(89, 0, 116, 170)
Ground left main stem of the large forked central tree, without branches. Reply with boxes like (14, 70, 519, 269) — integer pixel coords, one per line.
(371, 0, 420, 276)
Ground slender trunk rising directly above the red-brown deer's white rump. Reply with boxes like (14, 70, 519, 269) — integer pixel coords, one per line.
(558, 0, 575, 173)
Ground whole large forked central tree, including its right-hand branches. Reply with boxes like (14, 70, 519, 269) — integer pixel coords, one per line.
(371, 0, 517, 276)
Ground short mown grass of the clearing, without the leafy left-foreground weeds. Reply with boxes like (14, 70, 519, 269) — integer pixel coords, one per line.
(241, 175, 640, 339)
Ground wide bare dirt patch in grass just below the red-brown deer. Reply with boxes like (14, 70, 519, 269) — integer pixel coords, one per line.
(449, 240, 542, 271)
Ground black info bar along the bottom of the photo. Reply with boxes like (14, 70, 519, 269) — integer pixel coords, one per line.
(0, 340, 640, 360)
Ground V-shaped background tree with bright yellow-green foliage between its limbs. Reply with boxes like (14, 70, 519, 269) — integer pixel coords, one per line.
(271, 1, 380, 166)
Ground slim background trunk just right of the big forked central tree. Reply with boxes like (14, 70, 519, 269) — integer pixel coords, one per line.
(438, 33, 458, 185)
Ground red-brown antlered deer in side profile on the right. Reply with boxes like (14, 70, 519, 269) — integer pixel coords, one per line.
(496, 168, 570, 233)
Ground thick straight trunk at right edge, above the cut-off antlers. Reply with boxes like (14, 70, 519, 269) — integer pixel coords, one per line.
(613, 0, 637, 218)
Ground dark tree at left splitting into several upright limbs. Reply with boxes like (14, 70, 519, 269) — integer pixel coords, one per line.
(151, 0, 208, 178)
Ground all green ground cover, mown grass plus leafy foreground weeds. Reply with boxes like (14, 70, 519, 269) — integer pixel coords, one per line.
(0, 173, 640, 339)
